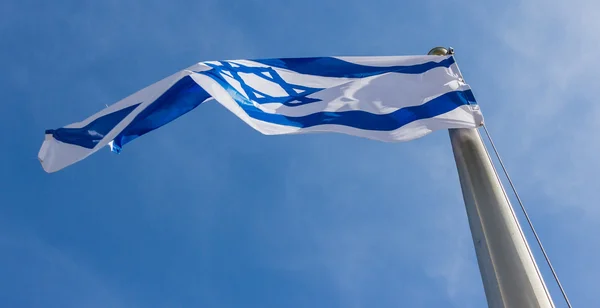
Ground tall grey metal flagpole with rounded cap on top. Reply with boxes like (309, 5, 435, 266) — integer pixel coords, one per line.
(429, 47, 554, 308)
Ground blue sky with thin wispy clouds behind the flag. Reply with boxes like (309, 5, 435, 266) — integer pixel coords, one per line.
(0, 0, 600, 307)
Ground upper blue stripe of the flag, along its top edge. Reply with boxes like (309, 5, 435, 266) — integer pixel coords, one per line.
(252, 57, 455, 78)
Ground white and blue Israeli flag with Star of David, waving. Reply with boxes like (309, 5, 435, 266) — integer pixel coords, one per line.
(38, 55, 483, 172)
